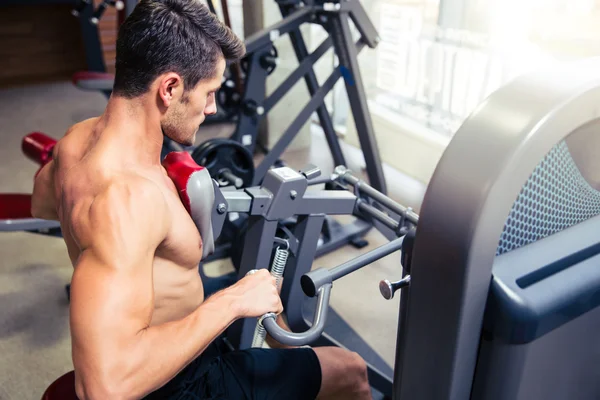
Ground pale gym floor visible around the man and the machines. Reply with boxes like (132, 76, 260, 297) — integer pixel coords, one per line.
(0, 82, 424, 400)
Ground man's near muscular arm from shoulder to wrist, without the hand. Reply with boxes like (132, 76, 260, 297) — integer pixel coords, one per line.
(71, 182, 244, 400)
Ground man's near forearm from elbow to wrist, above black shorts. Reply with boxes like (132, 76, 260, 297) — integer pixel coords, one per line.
(77, 290, 238, 399)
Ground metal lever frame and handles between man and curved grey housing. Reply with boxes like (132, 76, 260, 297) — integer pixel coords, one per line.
(200, 162, 418, 396)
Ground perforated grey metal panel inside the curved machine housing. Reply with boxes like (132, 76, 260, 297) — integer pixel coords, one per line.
(496, 141, 600, 255)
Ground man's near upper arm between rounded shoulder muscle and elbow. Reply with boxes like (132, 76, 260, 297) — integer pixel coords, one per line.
(70, 249, 153, 376)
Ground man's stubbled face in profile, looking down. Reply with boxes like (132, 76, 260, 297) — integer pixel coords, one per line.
(162, 59, 225, 146)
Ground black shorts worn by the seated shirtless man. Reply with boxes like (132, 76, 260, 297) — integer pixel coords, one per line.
(145, 339, 321, 400)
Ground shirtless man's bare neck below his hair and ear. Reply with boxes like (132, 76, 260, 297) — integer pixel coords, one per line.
(99, 95, 163, 165)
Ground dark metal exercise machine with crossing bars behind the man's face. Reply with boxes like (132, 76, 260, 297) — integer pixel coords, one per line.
(70, 0, 386, 189)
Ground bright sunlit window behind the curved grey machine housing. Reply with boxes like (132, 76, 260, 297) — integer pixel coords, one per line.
(333, 0, 600, 183)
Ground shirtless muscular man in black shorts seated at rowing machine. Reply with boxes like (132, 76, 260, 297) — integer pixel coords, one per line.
(32, 0, 371, 400)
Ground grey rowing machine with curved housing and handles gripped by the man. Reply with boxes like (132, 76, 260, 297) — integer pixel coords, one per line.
(0, 59, 600, 400)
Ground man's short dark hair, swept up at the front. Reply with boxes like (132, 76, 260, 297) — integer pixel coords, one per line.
(113, 0, 246, 98)
